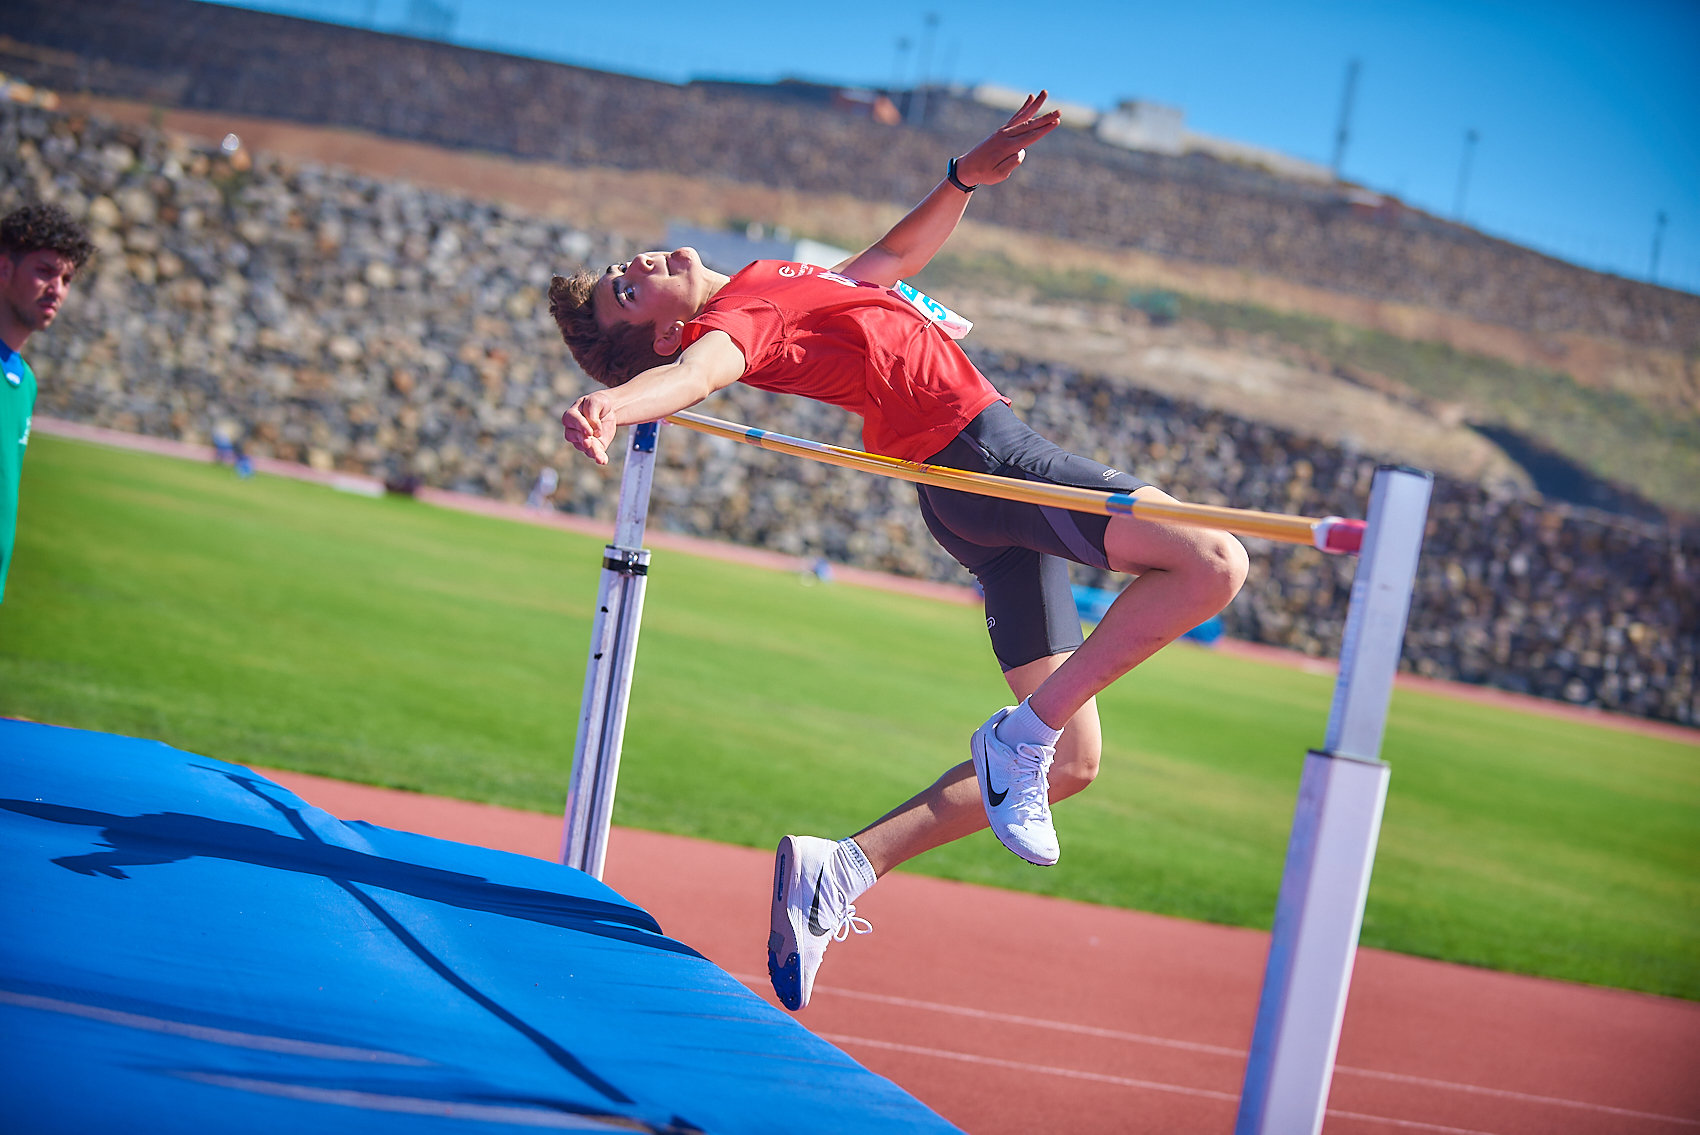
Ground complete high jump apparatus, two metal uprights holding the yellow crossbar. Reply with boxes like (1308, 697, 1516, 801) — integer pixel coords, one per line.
(561, 413, 1433, 1135)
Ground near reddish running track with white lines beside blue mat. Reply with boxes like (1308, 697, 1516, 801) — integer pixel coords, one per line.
(267, 771, 1700, 1135)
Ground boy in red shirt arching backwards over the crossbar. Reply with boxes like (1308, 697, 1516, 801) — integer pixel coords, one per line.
(549, 92, 1246, 1009)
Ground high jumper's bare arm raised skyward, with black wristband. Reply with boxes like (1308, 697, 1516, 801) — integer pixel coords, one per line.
(836, 90, 1063, 287)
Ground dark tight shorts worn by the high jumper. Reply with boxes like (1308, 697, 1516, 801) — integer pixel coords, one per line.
(915, 403, 1146, 669)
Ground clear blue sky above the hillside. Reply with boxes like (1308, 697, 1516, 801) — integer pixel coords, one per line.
(215, 0, 1700, 292)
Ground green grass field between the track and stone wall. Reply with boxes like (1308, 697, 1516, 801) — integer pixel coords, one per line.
(0, 435, 1700, 999)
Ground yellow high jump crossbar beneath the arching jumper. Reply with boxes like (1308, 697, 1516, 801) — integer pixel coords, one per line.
(668, 411, 1363, 554)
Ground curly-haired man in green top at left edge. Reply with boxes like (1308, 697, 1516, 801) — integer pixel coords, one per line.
(0, 204, 94, 601)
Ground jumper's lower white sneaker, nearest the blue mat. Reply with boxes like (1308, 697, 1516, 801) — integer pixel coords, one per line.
(767, 836, 874, 1013)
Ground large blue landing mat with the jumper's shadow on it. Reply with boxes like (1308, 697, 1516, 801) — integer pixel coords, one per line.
(0, 720, 957, 1135)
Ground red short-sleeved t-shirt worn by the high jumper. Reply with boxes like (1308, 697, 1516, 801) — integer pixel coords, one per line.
(683, 260, 1010, 460)
